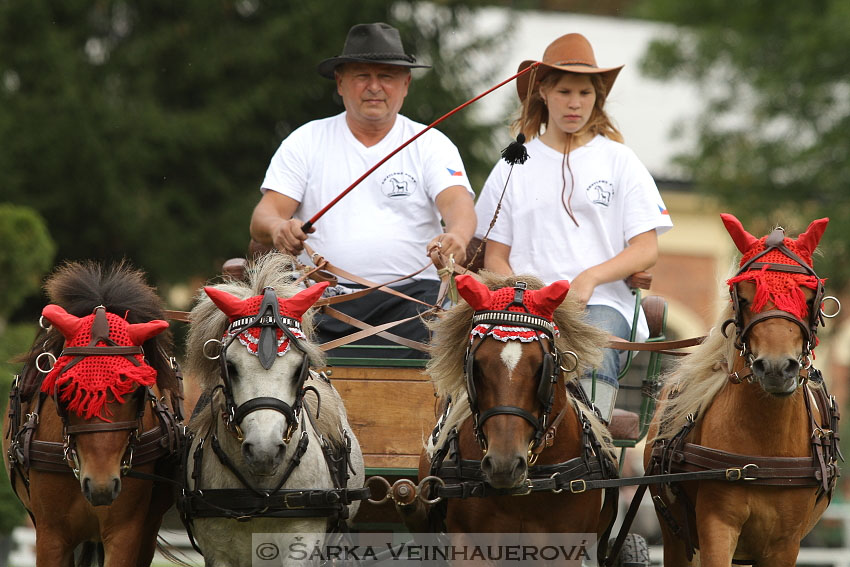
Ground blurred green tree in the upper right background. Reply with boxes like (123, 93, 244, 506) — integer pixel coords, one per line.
(641, 0, 850, 292)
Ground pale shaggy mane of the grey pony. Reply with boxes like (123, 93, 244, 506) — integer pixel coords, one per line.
(186, 252, 325, 391)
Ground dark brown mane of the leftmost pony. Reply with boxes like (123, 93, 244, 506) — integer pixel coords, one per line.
(21, 260, 179, 399)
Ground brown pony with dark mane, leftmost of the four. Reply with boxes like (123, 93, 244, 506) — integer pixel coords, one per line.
(3, 262, 182, 566)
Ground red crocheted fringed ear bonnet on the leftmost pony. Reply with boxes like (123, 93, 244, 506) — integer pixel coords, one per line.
(41, 304, 168, 421)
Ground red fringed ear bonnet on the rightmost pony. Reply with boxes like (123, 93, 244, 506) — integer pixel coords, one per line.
(720, 213, 829, 320)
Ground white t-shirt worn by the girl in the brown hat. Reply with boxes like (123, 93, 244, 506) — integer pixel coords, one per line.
(475, 136, 673, 340)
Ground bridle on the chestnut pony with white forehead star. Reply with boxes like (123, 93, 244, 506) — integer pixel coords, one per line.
(464, 282, 575, 455)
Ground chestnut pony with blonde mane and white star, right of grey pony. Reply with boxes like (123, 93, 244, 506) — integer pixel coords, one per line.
(407, 272, 616, 560)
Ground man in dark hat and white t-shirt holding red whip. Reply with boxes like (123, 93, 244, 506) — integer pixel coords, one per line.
(251, 23, 476, 356)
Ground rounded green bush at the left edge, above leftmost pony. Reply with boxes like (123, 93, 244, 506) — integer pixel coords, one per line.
(0, 203, 56, 322)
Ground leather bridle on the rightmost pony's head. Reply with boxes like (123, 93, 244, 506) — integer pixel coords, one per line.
(721, 228, 841, 380)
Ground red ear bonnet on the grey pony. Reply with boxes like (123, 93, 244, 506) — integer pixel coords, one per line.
(204, 282, 328, 356)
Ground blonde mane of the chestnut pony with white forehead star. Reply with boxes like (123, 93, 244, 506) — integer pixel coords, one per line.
(425, 271, 613, 462)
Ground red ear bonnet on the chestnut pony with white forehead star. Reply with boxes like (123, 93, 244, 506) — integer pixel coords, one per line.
(455, 274, 570, 342)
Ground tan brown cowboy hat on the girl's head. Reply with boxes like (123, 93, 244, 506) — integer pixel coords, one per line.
(516, 33, 623, 100)
